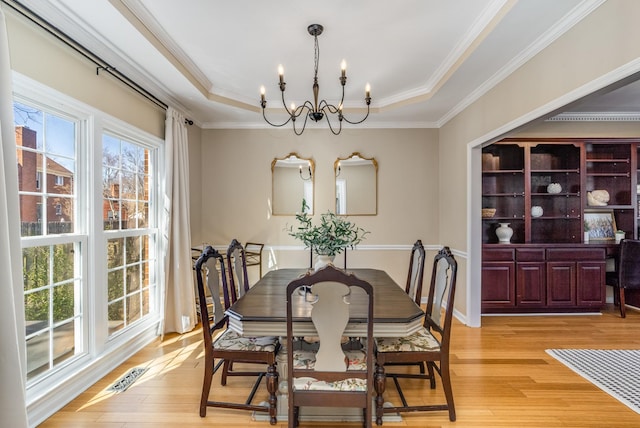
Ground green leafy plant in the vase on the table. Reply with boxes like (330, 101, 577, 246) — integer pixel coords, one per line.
(286, 199, 369, 256)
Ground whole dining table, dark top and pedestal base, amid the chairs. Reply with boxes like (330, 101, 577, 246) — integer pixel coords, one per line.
(226, 268, 424, 422)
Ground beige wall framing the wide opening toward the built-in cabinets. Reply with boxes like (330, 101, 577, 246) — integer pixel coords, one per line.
(439, 1, 640, 325)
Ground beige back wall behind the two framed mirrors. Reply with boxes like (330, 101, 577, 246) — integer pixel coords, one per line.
(198, 129, 439, 284)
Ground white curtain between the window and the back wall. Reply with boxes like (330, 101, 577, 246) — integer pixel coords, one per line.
(162, 107, 196, 333)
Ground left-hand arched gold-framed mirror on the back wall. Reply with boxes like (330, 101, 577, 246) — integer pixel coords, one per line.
(271, 152, 315, 215)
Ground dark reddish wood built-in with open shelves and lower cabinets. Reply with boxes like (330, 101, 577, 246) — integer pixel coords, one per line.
(482, 139, 640, 313)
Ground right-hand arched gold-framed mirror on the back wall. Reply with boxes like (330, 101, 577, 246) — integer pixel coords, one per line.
(333, 152, 378, 215)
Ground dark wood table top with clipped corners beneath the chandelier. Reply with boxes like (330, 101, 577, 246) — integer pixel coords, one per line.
(227, 269, 424, 336)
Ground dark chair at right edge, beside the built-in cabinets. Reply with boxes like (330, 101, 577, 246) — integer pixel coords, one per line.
(606, 239, 640, 318)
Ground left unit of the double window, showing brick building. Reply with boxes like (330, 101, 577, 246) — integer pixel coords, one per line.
(14, 102, 81, 379)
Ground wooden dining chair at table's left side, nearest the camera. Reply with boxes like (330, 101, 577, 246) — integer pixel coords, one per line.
(195, 246, 280, 425)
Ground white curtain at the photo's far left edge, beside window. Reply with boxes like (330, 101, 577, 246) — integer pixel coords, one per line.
(0, 8, 28, 428)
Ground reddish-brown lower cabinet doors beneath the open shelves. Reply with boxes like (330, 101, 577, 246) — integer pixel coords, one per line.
(482, 244, 612, 313)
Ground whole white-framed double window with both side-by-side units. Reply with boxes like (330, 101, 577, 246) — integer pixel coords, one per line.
(14, 77, 162, 394)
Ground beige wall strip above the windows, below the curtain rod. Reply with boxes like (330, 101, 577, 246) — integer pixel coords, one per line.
(3, 8, 165, 138)
